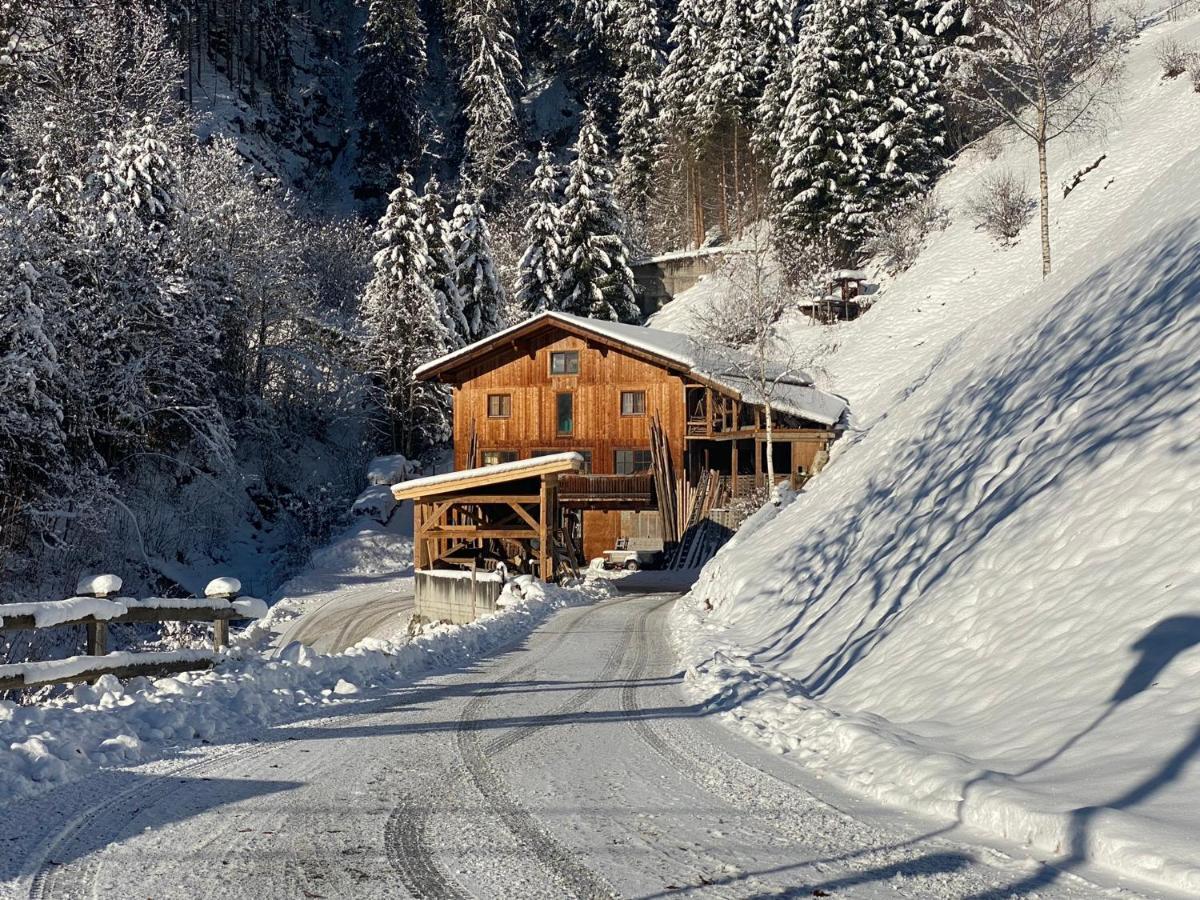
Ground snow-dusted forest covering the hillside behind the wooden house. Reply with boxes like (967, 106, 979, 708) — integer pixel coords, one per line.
(0, 0, 1110, 607)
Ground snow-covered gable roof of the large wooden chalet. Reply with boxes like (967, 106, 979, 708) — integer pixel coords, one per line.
(415, 311, 848, 425)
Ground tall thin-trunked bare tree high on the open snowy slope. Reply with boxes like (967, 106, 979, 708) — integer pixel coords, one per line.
(956, 0, 1121, 277)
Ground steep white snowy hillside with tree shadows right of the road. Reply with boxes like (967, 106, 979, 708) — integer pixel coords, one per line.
(672, 10, 1200, 892)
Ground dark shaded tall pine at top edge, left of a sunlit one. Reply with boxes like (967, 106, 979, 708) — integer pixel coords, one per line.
(355, 0, 427, 199)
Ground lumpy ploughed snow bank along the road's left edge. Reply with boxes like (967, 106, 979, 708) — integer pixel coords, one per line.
(0, 577, 610, 802)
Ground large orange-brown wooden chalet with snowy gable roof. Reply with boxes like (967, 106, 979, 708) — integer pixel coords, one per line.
(408, 312, 846, 577)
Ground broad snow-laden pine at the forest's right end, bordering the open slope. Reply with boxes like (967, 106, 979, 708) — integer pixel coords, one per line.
(772, 0, 942, 259)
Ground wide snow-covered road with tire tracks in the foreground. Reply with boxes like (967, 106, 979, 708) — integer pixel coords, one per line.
(0, 594, 1156, 900)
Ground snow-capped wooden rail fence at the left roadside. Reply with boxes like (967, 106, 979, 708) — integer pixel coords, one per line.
(0, 575, 266, 691)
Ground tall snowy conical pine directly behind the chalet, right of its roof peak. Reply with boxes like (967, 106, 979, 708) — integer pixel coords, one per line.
(558, 108, 641, 322)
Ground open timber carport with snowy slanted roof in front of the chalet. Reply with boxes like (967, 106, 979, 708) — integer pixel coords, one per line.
(391, 452, 583, 581)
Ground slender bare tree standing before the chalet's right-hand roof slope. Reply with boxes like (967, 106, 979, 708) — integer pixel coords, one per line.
(691, 226, 804, 501)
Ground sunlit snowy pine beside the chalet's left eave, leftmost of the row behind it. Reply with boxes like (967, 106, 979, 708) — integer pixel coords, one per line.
(362, 172, 449, 457)
